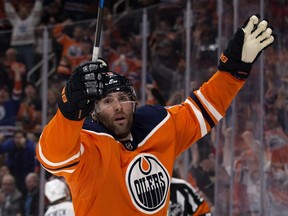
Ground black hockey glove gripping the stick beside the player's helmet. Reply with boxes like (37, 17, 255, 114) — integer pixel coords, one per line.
(58, 59, 108, 121)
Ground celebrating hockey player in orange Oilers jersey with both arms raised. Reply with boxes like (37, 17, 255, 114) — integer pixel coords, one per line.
(37, 15, 274, 216)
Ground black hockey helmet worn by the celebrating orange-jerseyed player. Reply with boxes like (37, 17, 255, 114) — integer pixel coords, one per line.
(102, 71, 137, 101)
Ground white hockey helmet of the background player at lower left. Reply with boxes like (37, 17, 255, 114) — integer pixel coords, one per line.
(45, 178, 67, 203)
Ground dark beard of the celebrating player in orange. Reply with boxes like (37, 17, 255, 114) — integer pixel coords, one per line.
(97, 112, 133, 141)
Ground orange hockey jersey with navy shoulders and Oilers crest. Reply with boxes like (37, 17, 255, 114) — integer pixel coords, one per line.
(37, 71, 244, 216)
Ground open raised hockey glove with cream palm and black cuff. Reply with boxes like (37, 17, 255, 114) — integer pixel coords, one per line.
(218, 15, 274, 80)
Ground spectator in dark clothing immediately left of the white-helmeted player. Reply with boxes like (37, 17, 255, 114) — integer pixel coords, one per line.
(24, 172, 39, 216)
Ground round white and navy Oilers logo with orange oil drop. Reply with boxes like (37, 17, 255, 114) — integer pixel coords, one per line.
(126, 154, 170, 214)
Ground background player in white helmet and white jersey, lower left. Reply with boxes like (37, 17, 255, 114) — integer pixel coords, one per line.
(44, 178, 75, 216)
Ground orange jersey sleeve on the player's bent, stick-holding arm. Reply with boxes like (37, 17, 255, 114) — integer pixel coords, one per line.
(36, 109, 84, 180)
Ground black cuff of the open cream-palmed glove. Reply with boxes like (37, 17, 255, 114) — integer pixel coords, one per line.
(218, 51, 252, 80)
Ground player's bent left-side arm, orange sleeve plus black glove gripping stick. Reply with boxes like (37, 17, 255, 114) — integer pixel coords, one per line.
(36, 59, 107, 179)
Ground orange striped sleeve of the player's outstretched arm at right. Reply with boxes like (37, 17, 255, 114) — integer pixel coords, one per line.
(168, 71, 245, 156)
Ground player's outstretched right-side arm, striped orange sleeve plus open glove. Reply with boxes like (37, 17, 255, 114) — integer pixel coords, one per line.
(169, 15, 274, 152)
